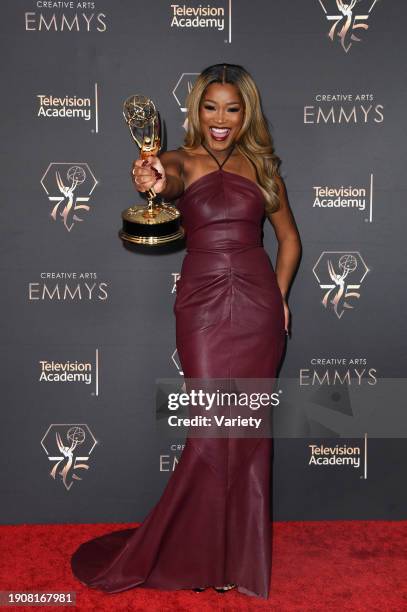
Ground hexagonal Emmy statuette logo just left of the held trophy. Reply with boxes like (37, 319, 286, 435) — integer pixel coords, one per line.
(41, 162, 98, 232)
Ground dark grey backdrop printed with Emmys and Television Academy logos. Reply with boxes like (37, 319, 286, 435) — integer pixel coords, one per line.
(0, 0, 407, 524)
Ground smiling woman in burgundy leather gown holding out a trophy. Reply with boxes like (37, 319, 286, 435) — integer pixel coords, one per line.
(72, 64, 301, 599)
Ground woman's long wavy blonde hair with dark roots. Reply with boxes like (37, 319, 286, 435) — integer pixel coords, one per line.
(181, 64, 281, 216)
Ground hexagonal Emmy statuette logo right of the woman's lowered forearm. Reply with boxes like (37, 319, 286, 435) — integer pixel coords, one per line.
(313, 251, 369, 319)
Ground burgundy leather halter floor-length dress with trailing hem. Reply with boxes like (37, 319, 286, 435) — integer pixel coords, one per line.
(71, 148, 286, 599)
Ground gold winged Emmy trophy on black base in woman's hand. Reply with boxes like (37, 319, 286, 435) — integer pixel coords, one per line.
(119, 95, 184, 246)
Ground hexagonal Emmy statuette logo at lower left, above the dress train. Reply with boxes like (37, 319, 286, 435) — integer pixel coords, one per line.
(41, 423, 97, 491)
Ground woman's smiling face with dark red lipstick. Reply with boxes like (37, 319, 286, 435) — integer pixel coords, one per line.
(199, 83, 244, 151)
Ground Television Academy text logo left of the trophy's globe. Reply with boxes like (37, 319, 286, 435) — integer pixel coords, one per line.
(36, 83, 99, 134)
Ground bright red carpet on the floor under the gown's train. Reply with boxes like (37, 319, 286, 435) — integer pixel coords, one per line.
(0, 521, 407, 612)
